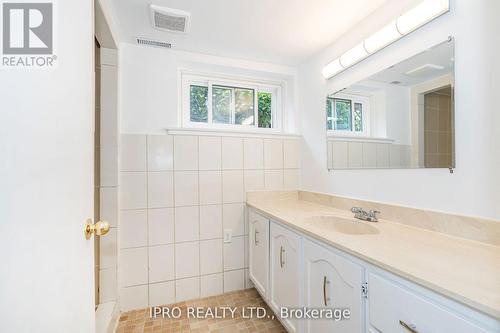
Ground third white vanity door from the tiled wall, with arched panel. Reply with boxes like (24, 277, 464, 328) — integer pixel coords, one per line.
(304, 240, 363, 333)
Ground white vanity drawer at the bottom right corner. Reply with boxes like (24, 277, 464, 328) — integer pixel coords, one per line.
(368, 273, 487, 333)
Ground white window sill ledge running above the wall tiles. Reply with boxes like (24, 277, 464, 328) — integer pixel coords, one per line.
(165, 127, 302, 139)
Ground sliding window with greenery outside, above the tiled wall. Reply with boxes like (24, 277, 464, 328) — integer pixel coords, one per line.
(182, 74, 281, 129)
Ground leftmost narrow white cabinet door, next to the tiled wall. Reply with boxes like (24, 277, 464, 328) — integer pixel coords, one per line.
(248, 209, 269, 299)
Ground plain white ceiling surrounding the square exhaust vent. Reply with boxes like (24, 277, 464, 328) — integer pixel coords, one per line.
(112, 0, 387, 65)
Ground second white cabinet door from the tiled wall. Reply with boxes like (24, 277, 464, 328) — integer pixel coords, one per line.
(269, 222, 300, 332)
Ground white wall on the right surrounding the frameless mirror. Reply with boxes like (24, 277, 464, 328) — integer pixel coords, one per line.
(299, 0, 500, 219)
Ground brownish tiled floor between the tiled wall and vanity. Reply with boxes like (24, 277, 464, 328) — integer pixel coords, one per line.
(116, 289, 286, 333)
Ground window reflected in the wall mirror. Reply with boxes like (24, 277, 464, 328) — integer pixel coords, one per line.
(326, 95, 370, 135)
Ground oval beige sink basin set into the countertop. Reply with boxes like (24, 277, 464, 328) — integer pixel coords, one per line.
(306, 216, 379, 235)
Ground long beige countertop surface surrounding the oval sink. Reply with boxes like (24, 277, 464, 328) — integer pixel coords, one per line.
(247, 194, 500, 319)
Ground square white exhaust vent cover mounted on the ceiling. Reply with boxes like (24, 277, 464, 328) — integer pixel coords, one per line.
(150, 5, 191, 32)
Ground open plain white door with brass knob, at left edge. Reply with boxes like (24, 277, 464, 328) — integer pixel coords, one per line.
(0, 0, 95, 333)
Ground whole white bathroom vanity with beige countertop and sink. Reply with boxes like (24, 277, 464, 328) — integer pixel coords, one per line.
(247, 192, 500, 333)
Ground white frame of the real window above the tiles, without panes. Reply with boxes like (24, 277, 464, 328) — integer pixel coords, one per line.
(180, 71, 284, 133)
